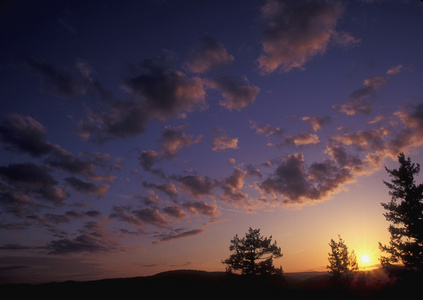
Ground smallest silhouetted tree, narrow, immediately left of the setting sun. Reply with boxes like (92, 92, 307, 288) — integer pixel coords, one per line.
(327, 235, 358, 286)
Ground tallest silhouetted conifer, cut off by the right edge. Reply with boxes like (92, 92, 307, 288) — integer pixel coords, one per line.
(379, 153, 423, 279)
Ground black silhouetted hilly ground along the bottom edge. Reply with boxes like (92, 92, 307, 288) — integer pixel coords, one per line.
(0, 270, 423, 300)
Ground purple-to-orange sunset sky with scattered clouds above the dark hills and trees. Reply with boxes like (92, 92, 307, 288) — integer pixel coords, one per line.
(0, 0, 423, 283)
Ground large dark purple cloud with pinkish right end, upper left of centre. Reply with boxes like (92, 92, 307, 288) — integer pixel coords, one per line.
(77, 57, 206, 143)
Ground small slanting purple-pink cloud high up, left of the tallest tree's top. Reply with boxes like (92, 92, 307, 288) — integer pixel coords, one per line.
(332, 76, 387, 116)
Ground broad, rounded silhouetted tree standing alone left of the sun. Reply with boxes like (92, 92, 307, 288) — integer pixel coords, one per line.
(222, 227, 283, 276)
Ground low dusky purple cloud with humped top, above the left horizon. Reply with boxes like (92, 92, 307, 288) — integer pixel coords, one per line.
(46, 222, 120, 255)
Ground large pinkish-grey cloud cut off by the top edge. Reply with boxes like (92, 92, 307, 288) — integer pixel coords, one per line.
(258, 0, 358, 74)
